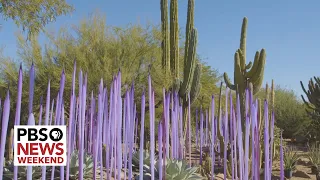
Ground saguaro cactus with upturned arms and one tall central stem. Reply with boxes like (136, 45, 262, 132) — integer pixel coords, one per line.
(224, 17, 266, 124)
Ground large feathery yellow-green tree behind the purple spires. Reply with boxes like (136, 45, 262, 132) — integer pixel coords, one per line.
(0, 14, 219, 128)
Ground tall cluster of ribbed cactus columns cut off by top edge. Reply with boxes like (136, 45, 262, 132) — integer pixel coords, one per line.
(161, 0, 201, 105)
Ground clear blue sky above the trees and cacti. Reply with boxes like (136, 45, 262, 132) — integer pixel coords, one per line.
(0, 0, 320, 95)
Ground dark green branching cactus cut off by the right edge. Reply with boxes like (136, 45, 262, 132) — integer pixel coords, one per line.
(300, 77, 320, 116)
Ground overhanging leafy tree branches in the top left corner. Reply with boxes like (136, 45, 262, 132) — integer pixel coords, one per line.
(0, 0, 73, 37)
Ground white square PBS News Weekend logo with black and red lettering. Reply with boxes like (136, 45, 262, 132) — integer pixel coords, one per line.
(14, 125, 67, 166)
